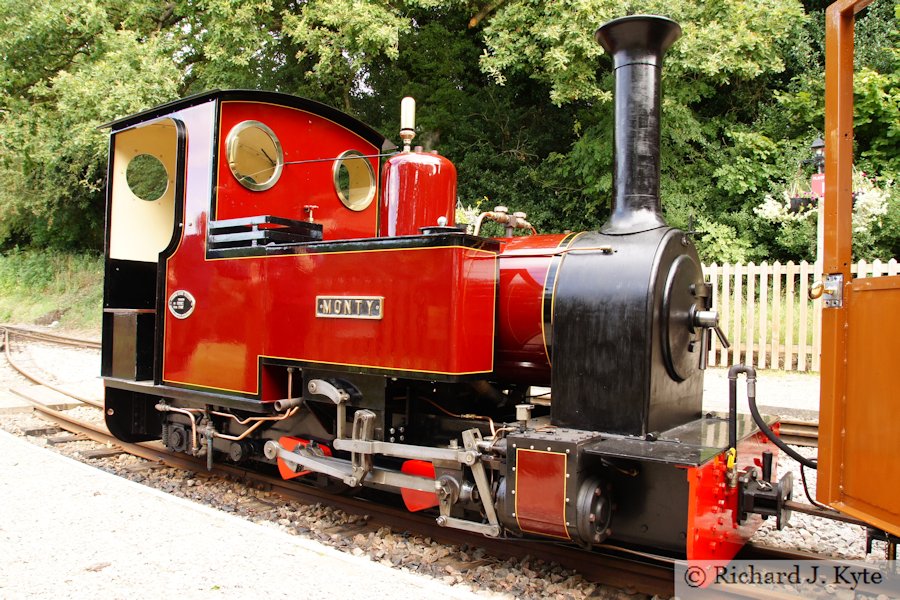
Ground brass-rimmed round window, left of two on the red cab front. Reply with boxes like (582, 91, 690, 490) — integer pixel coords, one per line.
(225, 121, 284, 192)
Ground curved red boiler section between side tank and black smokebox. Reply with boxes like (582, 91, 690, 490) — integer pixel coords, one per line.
(495, 234, 565, 385)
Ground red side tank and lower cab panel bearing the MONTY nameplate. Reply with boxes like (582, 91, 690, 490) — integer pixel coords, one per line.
(163, 244, 497, 400)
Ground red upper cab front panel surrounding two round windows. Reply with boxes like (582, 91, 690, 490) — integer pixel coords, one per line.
(216, 102, 379, 240)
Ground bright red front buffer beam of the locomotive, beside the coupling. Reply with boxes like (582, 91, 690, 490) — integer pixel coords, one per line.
(687, 423, 779, 565)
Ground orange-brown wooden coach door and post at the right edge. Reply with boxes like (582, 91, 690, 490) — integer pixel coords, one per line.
(817, 0, 900, 535)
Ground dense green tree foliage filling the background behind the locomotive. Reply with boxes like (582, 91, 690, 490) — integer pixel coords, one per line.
(0, 0, 900, 261)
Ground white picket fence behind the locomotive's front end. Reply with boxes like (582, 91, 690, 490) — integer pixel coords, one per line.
(703, 258, 900, 371)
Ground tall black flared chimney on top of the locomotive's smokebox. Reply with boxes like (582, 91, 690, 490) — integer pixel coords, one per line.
(594, 15, 681, 235)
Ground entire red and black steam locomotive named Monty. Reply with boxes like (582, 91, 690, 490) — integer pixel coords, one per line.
(102, 15, 791, 560)
